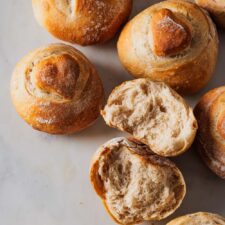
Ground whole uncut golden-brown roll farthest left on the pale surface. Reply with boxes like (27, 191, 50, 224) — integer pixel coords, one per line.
(11, 44, 104, 134)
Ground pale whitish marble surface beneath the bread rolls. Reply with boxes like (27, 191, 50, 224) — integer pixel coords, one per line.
(0, 0, 225, 225)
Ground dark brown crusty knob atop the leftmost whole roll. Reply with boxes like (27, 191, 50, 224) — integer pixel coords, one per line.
(33, 54, 80, 100)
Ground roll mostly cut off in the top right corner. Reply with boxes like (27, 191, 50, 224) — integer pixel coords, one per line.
(195, 0, 225, 28)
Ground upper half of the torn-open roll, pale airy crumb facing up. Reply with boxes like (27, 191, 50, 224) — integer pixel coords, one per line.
(101, 78, 197, 156)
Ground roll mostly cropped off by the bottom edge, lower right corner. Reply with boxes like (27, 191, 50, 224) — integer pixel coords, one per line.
(167, 212, 225, 225)
